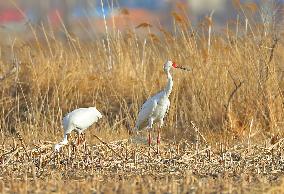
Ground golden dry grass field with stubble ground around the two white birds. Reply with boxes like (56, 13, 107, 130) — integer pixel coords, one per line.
(0, 1, 284, 193)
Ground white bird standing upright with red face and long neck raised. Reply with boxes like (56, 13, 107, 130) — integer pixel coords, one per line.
(134, 61, 189, 152)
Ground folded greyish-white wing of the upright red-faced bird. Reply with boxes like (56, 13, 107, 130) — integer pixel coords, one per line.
(135, 98, 158, 130)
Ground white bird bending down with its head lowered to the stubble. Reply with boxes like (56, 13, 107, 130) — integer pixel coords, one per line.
(54, 107, 102, 151)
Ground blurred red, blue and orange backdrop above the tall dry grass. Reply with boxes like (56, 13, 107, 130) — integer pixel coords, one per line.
(0, 0, 284, 42)
